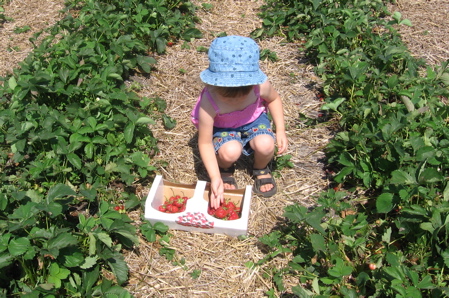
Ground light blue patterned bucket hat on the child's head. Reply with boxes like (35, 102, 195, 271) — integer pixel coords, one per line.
(200, 35, 267, 87)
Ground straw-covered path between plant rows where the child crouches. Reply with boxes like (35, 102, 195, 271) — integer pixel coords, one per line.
(127, 0, 329, 297)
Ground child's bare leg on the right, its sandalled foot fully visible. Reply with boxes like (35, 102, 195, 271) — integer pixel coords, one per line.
(249, 134, 275, 192)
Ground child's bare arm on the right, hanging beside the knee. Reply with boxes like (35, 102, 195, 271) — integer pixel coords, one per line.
(260, 81, 288, 154)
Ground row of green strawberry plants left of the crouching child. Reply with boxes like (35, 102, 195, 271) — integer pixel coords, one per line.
(0, 0, 201, 297)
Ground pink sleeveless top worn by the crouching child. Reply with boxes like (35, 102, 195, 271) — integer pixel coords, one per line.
(191, 85, 267, 128)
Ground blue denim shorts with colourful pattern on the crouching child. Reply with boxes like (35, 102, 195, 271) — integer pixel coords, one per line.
(213, 113, 275, 156)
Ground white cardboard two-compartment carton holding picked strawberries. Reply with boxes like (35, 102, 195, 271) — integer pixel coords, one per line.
(145, 175, 252, 237)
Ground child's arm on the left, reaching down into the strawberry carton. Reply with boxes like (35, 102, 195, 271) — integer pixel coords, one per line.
(198, 95, 224, 208)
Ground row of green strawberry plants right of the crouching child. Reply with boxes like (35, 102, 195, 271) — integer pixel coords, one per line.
(252, 0, 449, 297)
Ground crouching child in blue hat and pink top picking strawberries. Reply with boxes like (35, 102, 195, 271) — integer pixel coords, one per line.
(192, 36, 288, 208)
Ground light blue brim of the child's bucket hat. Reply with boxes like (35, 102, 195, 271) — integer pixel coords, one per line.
(200, 68, 267, 87)
